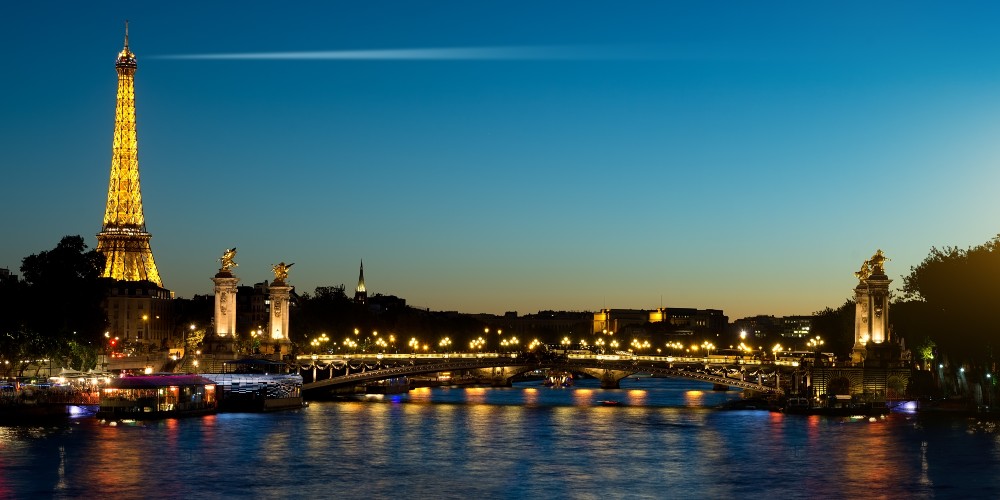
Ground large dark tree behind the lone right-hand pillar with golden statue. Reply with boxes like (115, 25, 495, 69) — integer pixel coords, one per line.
(897, 235, 1000, 362)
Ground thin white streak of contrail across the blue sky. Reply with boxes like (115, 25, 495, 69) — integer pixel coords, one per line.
(151, 46, 664, 61)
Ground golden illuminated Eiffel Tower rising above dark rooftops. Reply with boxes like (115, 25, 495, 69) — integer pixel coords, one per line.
(97, 22, 163, 287)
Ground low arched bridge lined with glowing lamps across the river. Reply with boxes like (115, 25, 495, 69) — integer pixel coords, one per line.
(297, 353, 794, 394)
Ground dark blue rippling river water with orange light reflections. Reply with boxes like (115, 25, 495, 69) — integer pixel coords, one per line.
(0, 378, 1000, 500)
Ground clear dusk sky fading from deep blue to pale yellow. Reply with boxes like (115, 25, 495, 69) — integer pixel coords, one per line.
(0, 0, 1000, 319)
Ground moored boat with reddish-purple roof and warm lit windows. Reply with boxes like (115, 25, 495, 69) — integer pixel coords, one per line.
(97, 374, 218, 420)
